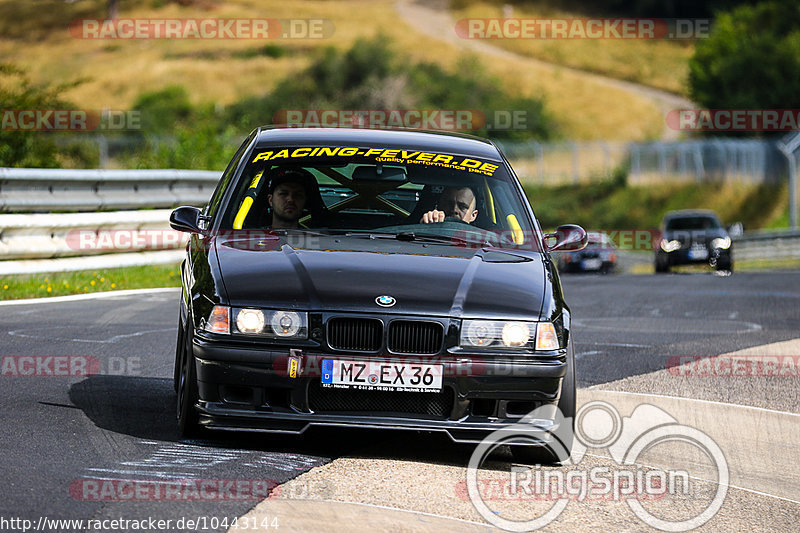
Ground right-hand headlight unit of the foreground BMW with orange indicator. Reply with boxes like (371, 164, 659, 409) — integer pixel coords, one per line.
(460, 320, 559, 351)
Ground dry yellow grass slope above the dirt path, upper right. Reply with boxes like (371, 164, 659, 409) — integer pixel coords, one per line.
(453, 3, 694, 96)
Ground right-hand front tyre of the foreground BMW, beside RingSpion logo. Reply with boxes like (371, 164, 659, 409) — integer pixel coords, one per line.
(511, 340, 576, 465)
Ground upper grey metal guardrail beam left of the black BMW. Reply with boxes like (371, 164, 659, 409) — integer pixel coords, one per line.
(0, 168, 221, 213)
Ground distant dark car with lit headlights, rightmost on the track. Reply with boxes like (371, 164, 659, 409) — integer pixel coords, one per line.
(655, 210, 733, 273)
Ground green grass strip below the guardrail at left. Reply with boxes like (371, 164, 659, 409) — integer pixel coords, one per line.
(0, 264, 181, 300)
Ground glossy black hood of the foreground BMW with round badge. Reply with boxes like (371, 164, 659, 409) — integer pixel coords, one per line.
(215, 237, 547, 319)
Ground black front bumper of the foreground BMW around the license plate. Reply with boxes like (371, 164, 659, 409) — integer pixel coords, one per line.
(192, 337, 567, 443)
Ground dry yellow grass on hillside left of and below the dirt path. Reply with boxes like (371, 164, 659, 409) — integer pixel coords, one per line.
(0, 0, 664, 140)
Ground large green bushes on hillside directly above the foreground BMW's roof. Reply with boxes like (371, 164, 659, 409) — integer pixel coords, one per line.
(228, 36, 557, 140)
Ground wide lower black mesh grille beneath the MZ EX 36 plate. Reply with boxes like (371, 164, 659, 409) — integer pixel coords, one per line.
(308, 380, 453, 419)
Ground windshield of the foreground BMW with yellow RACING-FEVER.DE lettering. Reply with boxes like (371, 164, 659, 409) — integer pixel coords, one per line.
(219, 146, 534, 247)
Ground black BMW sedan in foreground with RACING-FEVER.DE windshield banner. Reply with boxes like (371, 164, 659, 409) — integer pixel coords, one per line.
(170, 127, 586, 460)
